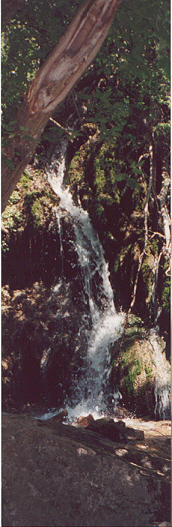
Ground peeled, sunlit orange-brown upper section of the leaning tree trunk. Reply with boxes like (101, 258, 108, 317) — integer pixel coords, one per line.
(27, 0, 121, 115)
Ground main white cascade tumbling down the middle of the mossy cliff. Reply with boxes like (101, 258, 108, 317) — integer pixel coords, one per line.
(47, 140, 124, 420)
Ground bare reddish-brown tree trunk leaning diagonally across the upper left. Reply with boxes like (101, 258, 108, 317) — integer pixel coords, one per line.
(1, 0, 121, 212)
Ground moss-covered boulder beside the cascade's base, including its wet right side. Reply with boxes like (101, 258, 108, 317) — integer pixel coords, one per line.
(112, 316, 170, 418)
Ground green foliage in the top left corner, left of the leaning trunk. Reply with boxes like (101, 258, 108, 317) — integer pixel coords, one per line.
(2, 0, 81, 127)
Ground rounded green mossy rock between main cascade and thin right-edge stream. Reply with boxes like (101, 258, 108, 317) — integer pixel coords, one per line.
(112, 316, 156, 417)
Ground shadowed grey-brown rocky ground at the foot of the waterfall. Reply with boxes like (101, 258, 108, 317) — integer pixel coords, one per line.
(2, 414, 171, 527)
